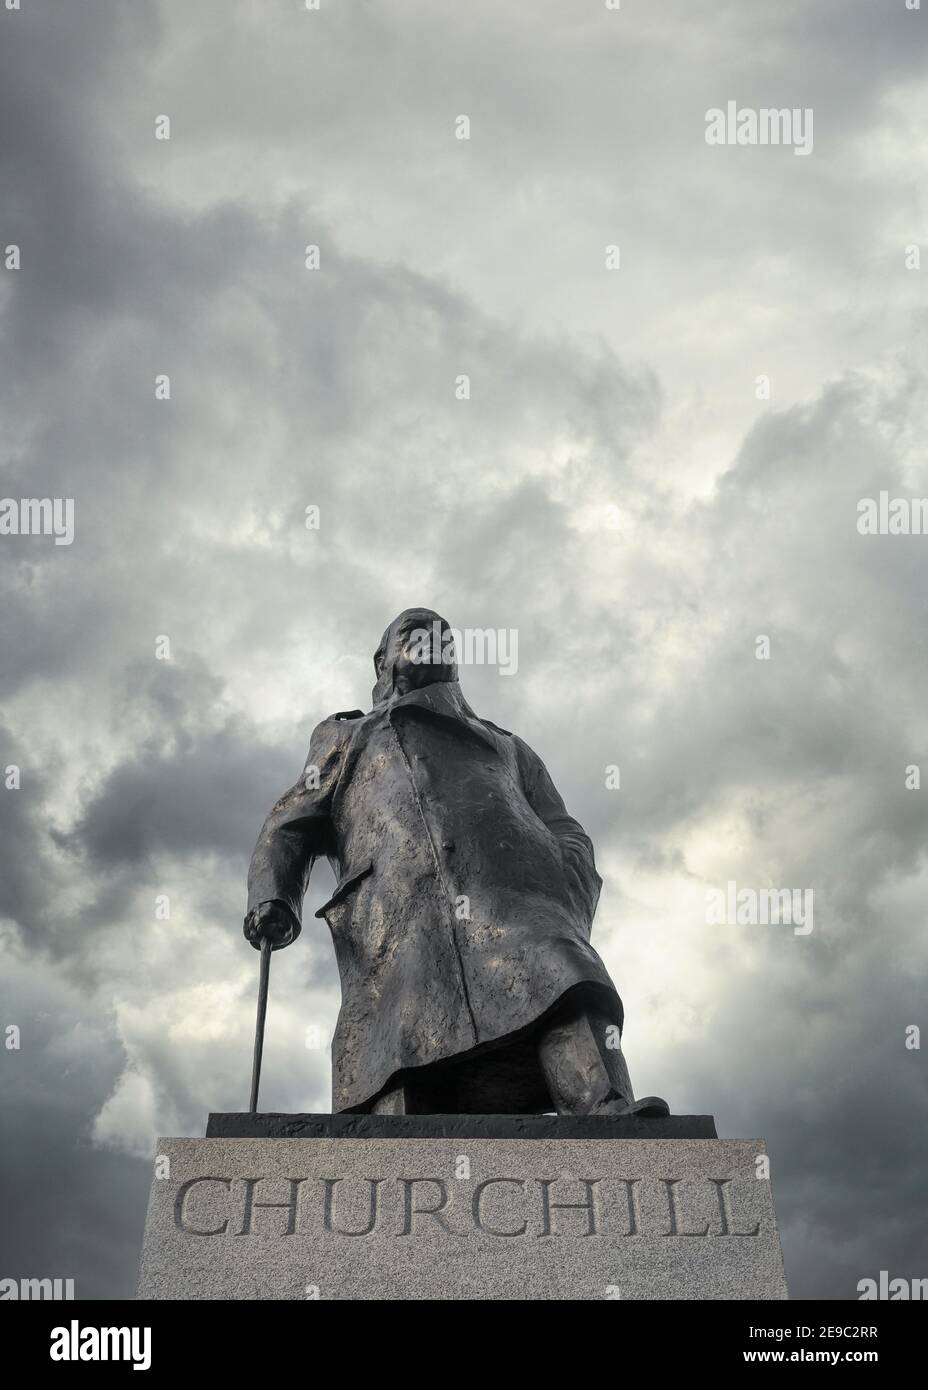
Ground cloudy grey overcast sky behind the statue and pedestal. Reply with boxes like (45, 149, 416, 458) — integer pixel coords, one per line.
(0, 0, 928, 1298)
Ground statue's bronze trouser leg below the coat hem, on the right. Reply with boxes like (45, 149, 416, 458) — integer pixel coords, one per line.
(538, 1006, 635, 1115)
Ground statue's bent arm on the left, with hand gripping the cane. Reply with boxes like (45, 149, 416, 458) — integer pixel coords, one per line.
(243, 719, 345, 951)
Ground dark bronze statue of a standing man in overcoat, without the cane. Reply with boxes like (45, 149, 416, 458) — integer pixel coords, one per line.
(245, 609, 668, 1115)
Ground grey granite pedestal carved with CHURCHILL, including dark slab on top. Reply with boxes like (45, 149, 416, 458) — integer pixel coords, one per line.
(139, 1116, 788, 1300)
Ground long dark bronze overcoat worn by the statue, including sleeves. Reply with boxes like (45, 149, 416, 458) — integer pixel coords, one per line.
(249, 656, 621, 1111)
